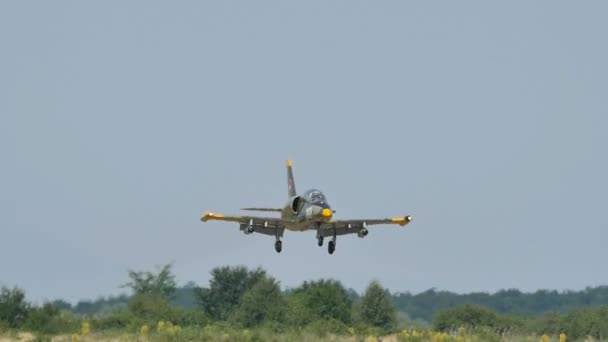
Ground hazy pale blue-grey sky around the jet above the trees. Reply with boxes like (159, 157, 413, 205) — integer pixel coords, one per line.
(0, 1, 608, 301)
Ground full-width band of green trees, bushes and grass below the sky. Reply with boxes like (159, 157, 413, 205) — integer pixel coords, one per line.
(0, 265, 608, 341)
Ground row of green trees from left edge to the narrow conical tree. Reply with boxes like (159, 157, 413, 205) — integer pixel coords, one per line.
(0, 265, 397, 334)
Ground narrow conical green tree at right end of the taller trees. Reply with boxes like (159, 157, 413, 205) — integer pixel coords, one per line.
(359, 281, 397, 331)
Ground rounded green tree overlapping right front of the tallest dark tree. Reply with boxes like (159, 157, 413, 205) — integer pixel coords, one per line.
(233, 276, 285, 328)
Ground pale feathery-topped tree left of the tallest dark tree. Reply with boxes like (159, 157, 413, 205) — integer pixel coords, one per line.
(122, 264, 177, 298)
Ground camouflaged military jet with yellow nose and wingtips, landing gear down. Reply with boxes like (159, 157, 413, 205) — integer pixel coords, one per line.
(201, 160, 412, 254)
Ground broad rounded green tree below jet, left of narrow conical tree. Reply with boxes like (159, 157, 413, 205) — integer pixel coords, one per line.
(288, 279, 353, 326)
